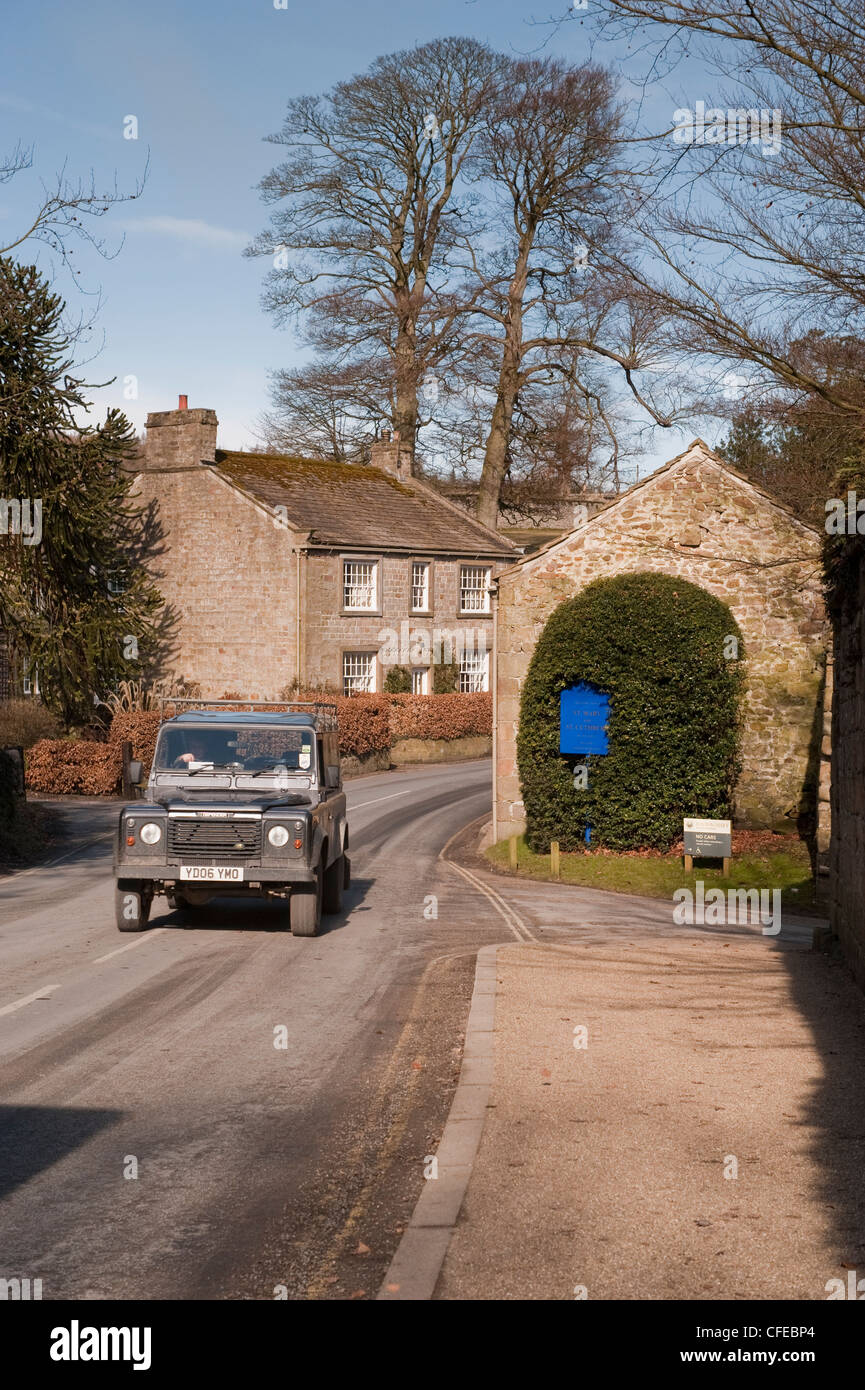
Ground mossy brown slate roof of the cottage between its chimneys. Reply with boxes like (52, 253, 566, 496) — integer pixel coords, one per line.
(214, 449, 520, 559)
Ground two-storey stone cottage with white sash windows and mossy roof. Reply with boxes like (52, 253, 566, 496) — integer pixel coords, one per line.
(135, 396, 519, 699)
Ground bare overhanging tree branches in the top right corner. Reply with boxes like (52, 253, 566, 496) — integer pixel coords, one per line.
(572, 0, 865, 418)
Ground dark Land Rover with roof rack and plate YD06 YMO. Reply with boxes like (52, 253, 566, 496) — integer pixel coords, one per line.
(114, 701, 349, 937)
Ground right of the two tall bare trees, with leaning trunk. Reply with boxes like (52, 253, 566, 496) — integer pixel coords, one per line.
(471, 58, 681, 527)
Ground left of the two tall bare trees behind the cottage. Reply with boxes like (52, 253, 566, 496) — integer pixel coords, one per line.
(248, 38, 502, 472)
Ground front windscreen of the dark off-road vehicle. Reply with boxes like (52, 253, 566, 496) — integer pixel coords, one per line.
(153, 724, 316, 777)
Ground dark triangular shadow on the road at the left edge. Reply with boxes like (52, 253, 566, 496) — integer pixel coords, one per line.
(0, 1105, 124, 1197)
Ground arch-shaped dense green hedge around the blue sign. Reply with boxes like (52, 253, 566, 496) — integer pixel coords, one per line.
(517, 573, 744, 853)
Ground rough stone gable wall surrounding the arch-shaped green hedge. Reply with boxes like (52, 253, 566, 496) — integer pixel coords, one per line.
(494, 439, 829, 849)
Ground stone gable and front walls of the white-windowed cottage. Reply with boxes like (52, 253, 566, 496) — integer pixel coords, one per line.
(139, 466, 492, 699)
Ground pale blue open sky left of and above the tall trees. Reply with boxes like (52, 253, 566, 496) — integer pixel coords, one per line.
(0, 0, 711, 471)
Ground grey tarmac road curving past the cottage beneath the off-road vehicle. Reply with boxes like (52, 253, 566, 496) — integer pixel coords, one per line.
(0, 762, 508, 1300)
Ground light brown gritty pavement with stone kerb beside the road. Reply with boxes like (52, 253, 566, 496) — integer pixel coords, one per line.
(378, 847, 865, 1300)
